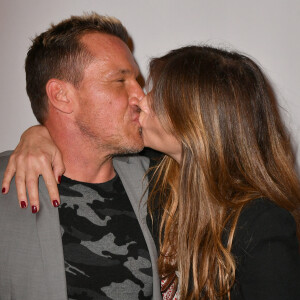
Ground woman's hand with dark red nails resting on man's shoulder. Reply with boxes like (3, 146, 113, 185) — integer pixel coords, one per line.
(2, 126, 65, 213)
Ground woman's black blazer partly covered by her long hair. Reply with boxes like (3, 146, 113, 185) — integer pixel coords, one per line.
(146, 151, 300, 300)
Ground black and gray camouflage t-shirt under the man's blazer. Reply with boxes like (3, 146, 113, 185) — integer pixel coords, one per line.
(59, 175, 152, 300)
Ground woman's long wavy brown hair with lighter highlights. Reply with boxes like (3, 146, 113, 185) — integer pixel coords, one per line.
(149, 46, 300, 300)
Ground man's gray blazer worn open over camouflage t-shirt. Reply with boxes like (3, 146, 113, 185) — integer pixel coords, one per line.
(0, 151, 161, 300)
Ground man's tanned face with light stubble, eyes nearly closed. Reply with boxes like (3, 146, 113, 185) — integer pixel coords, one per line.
(75, 33, 144, 154)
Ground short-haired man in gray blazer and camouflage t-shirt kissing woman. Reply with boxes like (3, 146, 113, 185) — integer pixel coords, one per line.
(0, 14, 161, 300)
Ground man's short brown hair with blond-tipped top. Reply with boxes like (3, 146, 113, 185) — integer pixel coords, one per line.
(25, 12, 128, 124)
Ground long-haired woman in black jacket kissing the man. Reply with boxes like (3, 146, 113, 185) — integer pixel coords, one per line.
(2, 46, 300, 300)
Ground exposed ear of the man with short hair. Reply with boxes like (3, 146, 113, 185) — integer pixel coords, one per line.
(46, 78, 73, 114)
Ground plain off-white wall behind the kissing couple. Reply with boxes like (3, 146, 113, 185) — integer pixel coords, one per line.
(0, 0, 300, 169)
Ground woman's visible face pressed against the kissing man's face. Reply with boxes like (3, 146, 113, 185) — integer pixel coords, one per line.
(139, 95, 181, 162)
